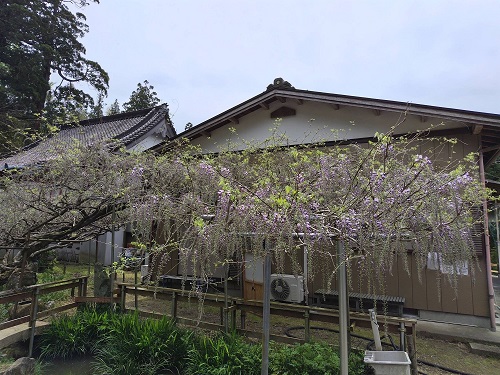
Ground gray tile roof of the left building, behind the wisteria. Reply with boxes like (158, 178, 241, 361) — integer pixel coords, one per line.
(0, 105, 175, 170)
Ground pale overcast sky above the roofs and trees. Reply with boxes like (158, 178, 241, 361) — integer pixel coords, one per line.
(77, 0, 500, 132)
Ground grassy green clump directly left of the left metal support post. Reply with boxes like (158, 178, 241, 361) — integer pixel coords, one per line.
(186, 334, 262, 375)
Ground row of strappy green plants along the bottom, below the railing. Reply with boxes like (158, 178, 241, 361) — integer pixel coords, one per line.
(40, 309, 370, 375)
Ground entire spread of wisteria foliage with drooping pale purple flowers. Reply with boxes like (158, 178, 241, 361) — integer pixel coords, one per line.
(0, 128, 487, 296)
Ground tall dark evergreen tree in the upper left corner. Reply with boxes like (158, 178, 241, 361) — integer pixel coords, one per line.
(0, 0, 109, 126)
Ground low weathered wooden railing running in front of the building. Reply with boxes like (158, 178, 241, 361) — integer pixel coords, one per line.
(0, 276, 417, 370)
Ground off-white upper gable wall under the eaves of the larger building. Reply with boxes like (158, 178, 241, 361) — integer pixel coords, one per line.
(193, 101, 459, 152)
